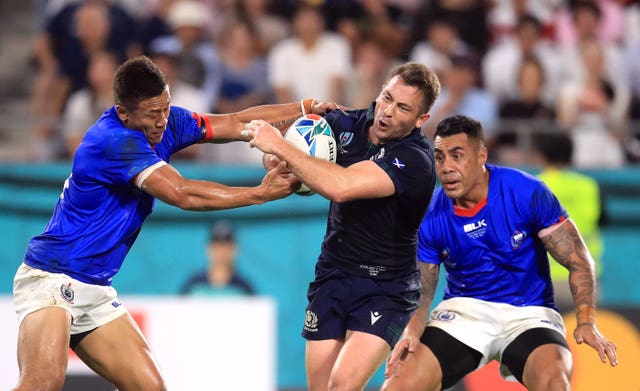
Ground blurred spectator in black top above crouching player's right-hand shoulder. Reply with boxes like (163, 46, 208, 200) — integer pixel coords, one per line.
(491, 57, 555, 166)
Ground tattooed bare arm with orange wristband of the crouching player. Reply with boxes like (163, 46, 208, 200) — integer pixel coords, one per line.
(540, 220, 618, 366)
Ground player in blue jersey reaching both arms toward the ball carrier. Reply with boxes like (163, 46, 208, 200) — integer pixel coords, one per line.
(14, 57, 323, 391)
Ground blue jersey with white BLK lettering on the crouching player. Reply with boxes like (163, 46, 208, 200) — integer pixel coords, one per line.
(418, 165, 568, 308)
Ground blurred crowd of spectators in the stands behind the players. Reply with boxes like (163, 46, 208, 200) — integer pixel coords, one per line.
(23, 0, 640, 168)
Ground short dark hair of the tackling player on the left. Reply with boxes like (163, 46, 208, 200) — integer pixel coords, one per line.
(113, 56, 167, 110)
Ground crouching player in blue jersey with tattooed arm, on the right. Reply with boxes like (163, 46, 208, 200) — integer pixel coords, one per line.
(383, 116, 617, 391)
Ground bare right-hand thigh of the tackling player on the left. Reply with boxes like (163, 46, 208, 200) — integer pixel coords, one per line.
(75, 313, 165, 391)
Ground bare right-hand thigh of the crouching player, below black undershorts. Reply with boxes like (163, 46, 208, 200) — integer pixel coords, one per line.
(522, 344, 573, 390)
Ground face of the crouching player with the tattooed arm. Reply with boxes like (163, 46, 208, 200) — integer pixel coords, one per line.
(434, 133, 488, 208)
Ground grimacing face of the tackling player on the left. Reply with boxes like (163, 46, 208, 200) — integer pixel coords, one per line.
(118, 87, 171, 145)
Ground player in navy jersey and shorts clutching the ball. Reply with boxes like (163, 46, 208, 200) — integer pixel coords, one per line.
(246, 63, 440, 391)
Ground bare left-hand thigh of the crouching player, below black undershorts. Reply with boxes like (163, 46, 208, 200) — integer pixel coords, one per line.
(382, 343, 442, 391)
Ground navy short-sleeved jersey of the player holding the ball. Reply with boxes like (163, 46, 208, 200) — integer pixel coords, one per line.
(320, 103, 435, 279)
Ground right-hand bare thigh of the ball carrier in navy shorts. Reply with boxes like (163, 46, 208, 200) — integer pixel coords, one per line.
(329, 331, 390, 390)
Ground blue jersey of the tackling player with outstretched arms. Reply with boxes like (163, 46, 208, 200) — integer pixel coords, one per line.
(24, 107, 203, 285)
